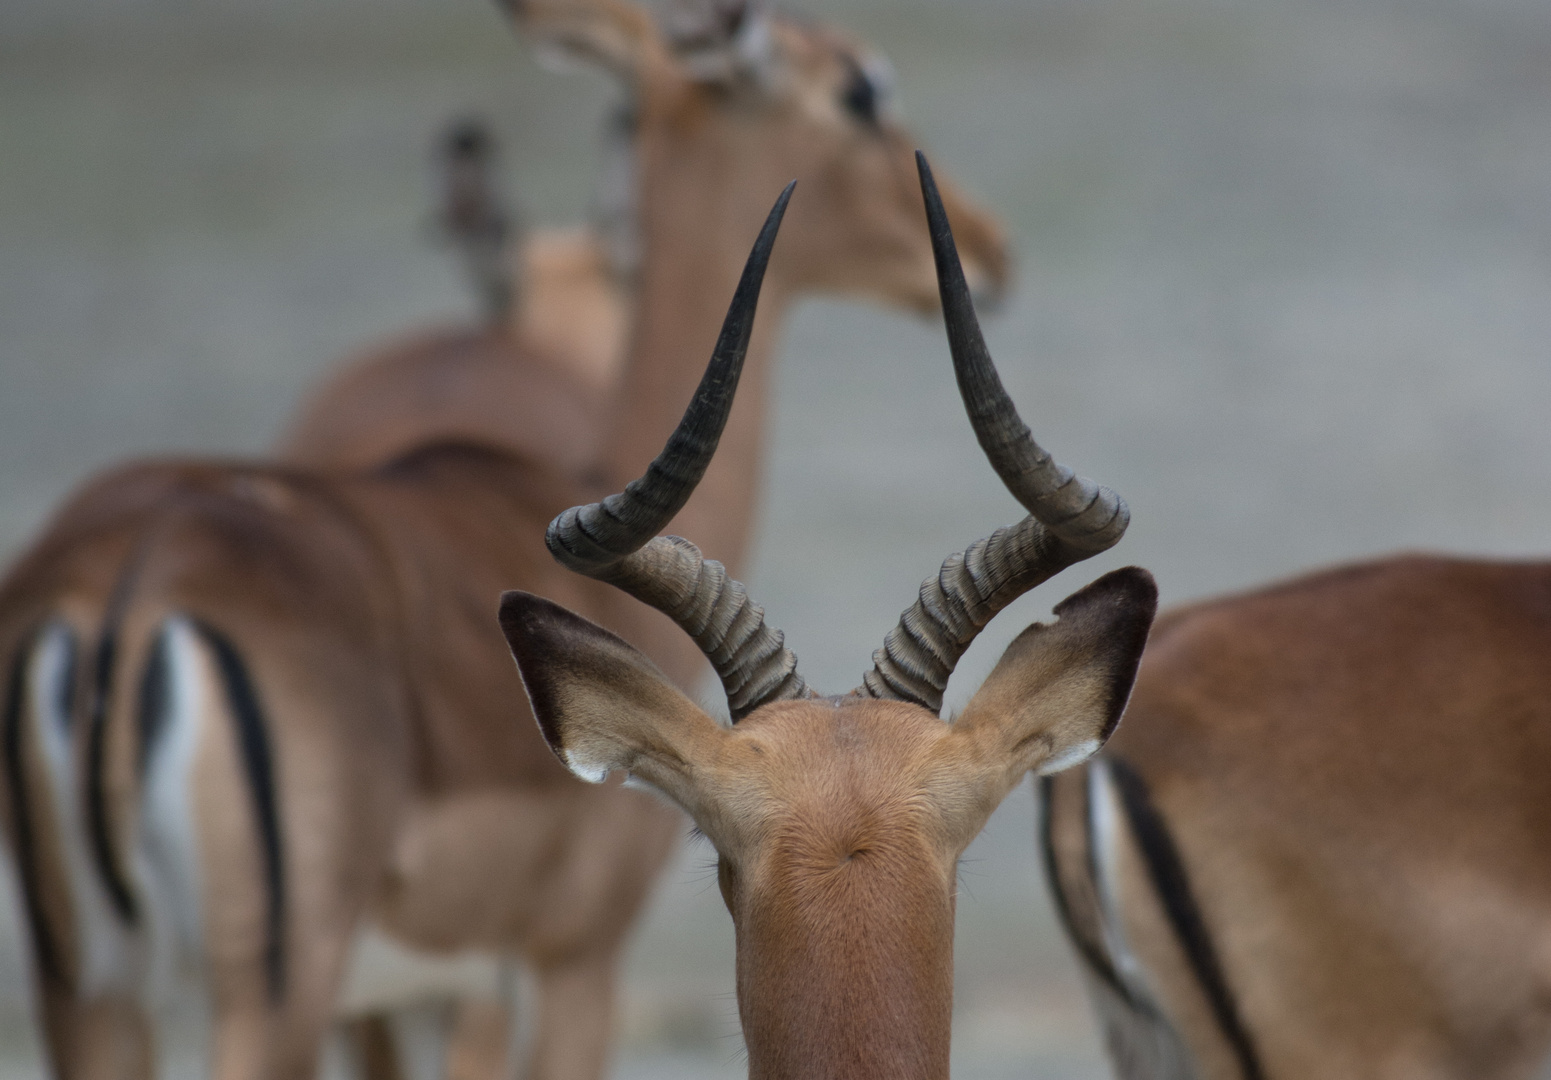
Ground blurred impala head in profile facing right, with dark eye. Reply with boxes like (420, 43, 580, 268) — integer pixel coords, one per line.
(501, 0, 1008, 310)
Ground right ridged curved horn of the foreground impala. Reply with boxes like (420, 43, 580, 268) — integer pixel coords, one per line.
(856, 152, 1131, 712)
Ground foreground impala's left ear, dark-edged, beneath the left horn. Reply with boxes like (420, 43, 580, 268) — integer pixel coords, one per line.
(501, 591, 727, 813)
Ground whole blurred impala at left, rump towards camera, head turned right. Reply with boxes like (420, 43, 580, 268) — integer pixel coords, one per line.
(0, 54, 1000, 1078)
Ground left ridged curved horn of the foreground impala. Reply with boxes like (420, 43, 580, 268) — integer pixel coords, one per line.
(544, 180, 810, 720)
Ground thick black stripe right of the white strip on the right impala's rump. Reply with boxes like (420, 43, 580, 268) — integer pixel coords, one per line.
(1107, 757, 1266, 1080)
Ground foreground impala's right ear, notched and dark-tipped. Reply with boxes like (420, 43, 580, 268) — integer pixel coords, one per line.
(954, 566, 1159, 788)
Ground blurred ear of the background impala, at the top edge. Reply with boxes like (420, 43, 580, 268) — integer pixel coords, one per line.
(496, 0, 667, 82)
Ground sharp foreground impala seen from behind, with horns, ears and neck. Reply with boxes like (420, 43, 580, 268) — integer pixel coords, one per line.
(501, 160, 1157, 1080)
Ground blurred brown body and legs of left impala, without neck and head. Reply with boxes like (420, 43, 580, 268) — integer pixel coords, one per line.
(0, 445, 642, 1077)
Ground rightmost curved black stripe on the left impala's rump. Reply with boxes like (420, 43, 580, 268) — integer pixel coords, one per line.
(194, 622, 285, 1001)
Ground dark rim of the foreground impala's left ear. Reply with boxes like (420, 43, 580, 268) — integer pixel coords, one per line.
(498, 590, 668, 768)
